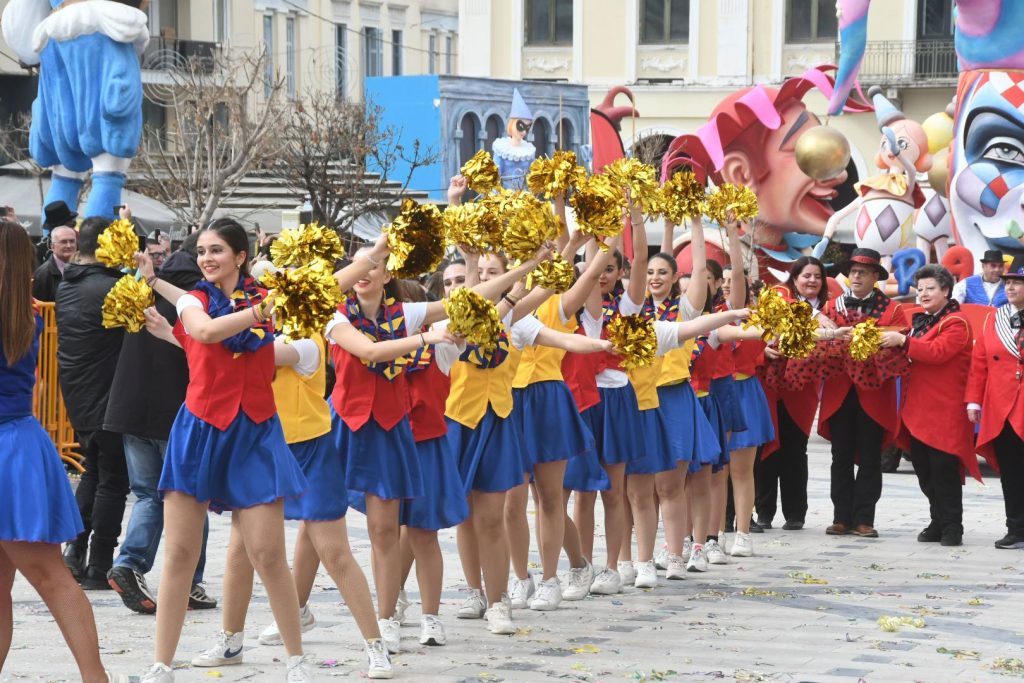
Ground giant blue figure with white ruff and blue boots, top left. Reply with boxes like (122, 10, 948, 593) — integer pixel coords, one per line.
(3, 0, 150, 217)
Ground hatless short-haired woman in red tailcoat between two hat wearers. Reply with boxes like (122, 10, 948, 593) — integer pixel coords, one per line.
(882, 264, 981, 546)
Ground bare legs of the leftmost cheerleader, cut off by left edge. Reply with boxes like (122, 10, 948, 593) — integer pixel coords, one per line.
(0, 541, 107, 683)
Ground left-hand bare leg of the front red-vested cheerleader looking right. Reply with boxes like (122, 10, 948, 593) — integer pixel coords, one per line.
(155, 490, 207, 666)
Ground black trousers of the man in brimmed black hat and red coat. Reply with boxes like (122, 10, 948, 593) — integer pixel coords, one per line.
(829, 388, 885, 526)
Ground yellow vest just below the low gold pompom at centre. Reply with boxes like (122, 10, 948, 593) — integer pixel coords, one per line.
(444, 344, 522, 429)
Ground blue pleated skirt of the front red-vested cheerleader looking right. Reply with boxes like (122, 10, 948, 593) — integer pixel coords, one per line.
(159, 405, 308, 512)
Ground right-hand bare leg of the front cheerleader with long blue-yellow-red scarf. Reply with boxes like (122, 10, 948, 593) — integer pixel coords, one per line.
(235, 500, 302, 656)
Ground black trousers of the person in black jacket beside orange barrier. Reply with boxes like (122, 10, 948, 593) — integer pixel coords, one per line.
(73, 430, 129, 574)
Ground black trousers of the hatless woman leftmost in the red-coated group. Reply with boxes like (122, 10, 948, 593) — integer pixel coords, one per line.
(754, 400, 808, 522)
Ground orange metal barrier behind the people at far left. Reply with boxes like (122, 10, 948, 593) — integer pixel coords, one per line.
(32, 301, 85, 472)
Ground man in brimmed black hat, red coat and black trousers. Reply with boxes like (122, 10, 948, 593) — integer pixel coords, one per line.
(818, 249, 907, 539)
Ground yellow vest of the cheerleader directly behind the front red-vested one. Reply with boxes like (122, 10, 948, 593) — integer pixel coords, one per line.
(272, 335, 331, 443)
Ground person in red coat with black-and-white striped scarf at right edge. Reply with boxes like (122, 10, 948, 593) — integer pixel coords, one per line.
(966, 267, 1024, 549)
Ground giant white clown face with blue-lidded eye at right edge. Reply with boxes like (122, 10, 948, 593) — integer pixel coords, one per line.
(949, 71, 1024, 257)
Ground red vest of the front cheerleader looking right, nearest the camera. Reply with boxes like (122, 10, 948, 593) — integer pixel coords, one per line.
(174, 291, 278, 431)
